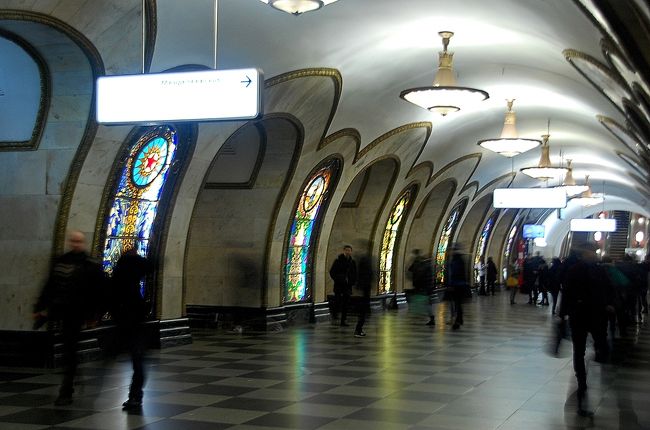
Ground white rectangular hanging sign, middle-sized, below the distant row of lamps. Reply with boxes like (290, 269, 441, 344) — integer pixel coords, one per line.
(493, 188, 566, 209)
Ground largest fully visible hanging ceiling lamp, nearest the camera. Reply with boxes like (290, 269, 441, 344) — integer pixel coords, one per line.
(399, 31, 490, 116)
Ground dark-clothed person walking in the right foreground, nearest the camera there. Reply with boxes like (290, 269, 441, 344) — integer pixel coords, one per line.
(560, 243, 614, 415)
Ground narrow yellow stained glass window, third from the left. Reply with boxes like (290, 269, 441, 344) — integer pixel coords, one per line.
(379, 186, 415, 294)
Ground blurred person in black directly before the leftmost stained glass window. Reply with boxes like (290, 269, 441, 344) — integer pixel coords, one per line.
(112, 249, 153, 409)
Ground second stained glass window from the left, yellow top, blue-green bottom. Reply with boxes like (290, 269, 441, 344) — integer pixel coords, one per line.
(284, 159, 340, 303)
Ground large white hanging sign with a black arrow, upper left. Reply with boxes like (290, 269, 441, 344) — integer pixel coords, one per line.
(97, 69, 263, 124)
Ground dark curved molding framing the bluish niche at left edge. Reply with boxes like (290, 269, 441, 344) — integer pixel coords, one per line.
(0, 28, 52, 152)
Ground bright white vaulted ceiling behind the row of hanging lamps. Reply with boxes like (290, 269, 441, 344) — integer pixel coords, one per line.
(149, 0, 648, 212)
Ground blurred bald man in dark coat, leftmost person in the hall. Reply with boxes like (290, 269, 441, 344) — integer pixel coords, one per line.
(34, 231, 104, 406)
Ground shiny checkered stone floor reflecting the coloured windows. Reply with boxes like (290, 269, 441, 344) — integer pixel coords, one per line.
(0, 293, 650, 430)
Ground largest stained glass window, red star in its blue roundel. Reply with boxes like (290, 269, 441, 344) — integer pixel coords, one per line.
(103, 126, 178, 274)
